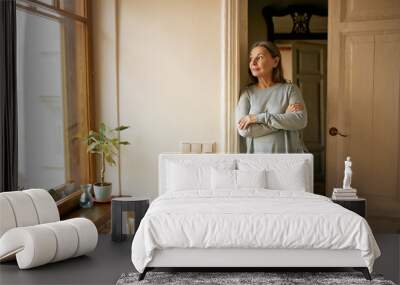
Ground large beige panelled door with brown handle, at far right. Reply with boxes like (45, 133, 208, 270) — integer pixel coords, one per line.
(326, 0, 400, 232)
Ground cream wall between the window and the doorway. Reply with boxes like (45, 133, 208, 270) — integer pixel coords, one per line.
(93, 0, 222, 198)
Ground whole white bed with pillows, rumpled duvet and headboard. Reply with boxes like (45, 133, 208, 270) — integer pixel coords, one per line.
(132, 154, 380, 280)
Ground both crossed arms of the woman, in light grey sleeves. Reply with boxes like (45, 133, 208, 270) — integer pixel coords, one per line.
(236, 86, 307, 138)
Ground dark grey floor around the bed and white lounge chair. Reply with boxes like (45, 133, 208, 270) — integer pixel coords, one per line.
(0, 234, 400, 285)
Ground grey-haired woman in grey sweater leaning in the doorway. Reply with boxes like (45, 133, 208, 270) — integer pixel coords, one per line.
(236, 42, 307, 153)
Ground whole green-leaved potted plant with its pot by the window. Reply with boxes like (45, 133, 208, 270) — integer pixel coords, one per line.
(85, 123, 129, 202)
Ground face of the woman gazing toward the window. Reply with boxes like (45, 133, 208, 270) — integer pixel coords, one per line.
(249, 47, 279, 78)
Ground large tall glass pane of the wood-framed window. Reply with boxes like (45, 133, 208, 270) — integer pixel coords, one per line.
(17, 10, 65, 188)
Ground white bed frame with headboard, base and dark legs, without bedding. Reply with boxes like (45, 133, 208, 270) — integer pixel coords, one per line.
(139, 154, 371, 280)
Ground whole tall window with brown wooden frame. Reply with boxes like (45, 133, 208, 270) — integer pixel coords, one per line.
(17, 0, 93, 189)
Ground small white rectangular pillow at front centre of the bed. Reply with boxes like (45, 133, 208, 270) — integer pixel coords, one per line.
(211, 168, 266, 190)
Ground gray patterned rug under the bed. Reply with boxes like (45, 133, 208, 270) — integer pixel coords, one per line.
(117, 271, 395, 285)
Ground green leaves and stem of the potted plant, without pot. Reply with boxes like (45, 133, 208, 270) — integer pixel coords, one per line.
(85, 123, 129, 186)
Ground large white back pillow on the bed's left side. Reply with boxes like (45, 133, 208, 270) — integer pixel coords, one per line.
(167, 160, 235, 191)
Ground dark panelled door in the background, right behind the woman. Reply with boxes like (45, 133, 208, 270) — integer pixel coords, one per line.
(292, 42, 326, 195)
